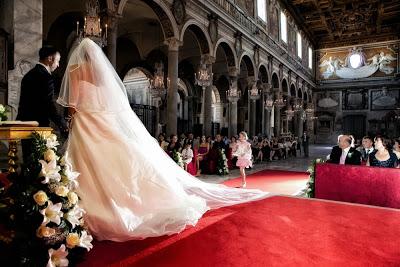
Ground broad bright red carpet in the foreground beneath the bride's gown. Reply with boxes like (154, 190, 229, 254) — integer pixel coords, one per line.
(81, 196, 400, 267)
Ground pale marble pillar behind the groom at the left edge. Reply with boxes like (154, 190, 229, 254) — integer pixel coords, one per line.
(8, 0, 43, 119)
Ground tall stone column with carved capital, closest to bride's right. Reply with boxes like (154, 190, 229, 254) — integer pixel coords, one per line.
(165, 38, 182, 136)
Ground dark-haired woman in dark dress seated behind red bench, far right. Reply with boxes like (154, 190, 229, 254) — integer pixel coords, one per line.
(367, 135, 399, 168)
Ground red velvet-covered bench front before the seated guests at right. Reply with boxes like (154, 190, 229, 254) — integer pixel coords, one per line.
(315, 163, 400, 209)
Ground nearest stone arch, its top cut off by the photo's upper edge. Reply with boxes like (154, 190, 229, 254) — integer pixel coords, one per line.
(115, 0, 179, 39)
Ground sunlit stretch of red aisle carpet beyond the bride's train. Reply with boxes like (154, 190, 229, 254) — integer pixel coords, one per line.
(224, 170, 308, 195)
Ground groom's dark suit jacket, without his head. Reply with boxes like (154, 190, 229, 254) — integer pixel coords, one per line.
(17, 64, 66, 131)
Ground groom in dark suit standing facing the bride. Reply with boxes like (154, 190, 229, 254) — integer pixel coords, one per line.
(17, 47, 68, 160)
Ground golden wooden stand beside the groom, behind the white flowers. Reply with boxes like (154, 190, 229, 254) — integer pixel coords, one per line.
(0, 126, 53, 173)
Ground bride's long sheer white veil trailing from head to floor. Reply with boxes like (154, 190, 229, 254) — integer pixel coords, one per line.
(57, 38, 269, 211)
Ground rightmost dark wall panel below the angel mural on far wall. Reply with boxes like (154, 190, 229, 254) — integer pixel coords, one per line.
(371, 89, 400, 110)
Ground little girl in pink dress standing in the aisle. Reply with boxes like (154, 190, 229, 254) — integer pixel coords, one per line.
(233, 132, 253, 188)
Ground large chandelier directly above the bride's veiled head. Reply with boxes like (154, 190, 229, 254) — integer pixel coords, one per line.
(76, 0, 108, 47)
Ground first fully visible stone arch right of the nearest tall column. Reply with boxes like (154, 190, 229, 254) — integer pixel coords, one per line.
(179, 19, 214, 55)
